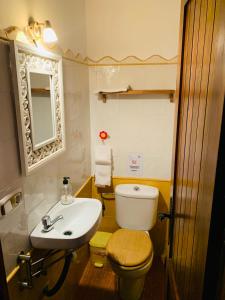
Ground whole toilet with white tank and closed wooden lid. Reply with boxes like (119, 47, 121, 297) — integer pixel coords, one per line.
(106, 184, 159, 300)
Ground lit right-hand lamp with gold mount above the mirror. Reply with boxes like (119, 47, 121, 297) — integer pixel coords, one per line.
(26, 18, 58, 44)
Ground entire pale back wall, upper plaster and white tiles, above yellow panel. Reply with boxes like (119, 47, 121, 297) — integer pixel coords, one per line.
(86, 0, 180, 180)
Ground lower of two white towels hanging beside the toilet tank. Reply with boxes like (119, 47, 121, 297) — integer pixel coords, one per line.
(95, 165, 112, 187)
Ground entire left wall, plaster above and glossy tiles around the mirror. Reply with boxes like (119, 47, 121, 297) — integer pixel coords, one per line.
(0, 0, 91, 273)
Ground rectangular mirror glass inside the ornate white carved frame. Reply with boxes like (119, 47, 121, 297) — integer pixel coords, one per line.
(28, 71, 56, 150)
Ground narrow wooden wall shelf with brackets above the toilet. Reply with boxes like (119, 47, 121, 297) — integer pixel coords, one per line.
(99, 89, 175, 103)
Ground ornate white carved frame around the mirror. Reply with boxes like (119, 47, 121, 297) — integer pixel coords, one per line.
(10, 41, 65, 175)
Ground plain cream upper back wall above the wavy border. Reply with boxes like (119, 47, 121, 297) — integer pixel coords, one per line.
(85, 0, 180, 59)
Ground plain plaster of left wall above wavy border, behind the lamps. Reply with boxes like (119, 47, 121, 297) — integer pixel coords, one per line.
(0, 0, 86, 55)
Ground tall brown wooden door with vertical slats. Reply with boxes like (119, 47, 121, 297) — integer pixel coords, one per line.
(169, 0, 224, 300)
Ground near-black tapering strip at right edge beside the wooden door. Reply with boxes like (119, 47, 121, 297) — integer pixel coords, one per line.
(203, 98, 225, 300)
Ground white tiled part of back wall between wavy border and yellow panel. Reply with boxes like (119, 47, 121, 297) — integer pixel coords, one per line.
(89, 65, 176, 179)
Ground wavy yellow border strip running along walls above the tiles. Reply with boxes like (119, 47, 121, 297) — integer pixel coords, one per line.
(0, 30, 177, 67)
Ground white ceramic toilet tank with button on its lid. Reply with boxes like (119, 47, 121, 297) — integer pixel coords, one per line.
(115, 184, 159, 230)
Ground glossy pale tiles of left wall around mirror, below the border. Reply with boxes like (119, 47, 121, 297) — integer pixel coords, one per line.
(0, 43, 91, 273)
